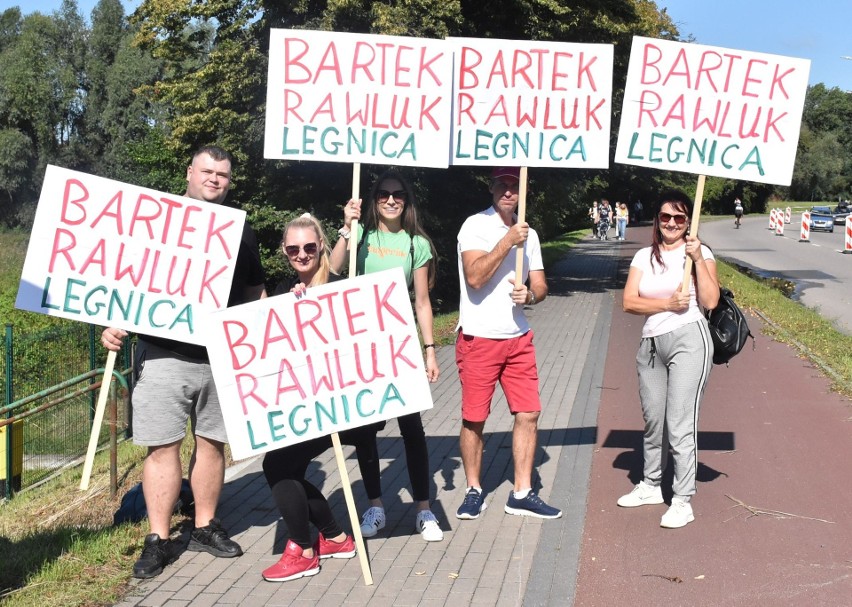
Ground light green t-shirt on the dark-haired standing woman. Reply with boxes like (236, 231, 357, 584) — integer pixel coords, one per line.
(355, 224, 432, 286)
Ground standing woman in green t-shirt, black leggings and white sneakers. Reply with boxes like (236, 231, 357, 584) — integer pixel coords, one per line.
(331, 170, 444, 542)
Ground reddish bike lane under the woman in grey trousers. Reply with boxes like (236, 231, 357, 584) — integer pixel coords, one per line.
(574, 229, 852, 606)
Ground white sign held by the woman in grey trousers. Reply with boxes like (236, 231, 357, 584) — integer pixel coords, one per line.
(615, 37, 810, 185)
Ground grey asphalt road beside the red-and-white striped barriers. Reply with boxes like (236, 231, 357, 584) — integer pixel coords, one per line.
(696, 216, 852, 335)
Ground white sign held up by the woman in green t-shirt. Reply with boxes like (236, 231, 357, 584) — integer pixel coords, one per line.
(264, 29, 453, 168)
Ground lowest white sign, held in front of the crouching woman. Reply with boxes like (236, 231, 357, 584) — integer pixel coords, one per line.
(207, 268, 432, 459)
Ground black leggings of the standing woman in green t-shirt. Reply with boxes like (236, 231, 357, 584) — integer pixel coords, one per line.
(356, 412, 429, 502)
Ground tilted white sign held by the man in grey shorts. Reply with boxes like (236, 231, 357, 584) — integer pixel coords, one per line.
(15, 166, 245, 344)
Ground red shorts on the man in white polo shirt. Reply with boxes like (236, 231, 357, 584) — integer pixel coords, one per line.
(456, 331, 541, 422)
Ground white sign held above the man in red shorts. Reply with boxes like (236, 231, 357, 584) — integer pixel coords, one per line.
(449, 38, 613, 168)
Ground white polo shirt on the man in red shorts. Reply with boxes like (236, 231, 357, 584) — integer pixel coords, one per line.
(457, 207, 544, 339)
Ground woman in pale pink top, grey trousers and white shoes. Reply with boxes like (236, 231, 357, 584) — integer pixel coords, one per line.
(618, 191, 719, 529)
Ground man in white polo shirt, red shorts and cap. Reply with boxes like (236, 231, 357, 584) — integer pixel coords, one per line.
(456, 167, 562, 519)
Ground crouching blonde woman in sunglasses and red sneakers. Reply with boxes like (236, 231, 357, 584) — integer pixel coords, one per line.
(256, 214, 385, 582)
